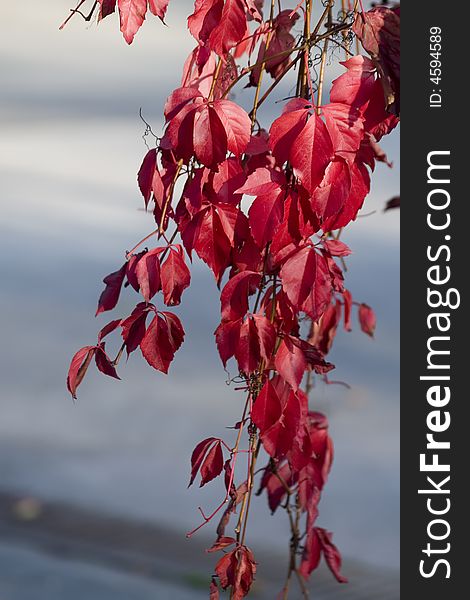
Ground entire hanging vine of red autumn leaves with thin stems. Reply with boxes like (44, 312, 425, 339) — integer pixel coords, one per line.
(67, 0, 400, 599)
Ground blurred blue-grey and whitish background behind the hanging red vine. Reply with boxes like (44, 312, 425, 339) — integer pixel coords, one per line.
(0, 0, 399, 600)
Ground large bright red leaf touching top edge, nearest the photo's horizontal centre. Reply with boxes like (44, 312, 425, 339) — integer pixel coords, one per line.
(209, 0, 246, 56)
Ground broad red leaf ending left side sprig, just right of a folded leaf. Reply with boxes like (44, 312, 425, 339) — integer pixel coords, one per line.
(140, 312, 184, 373)
